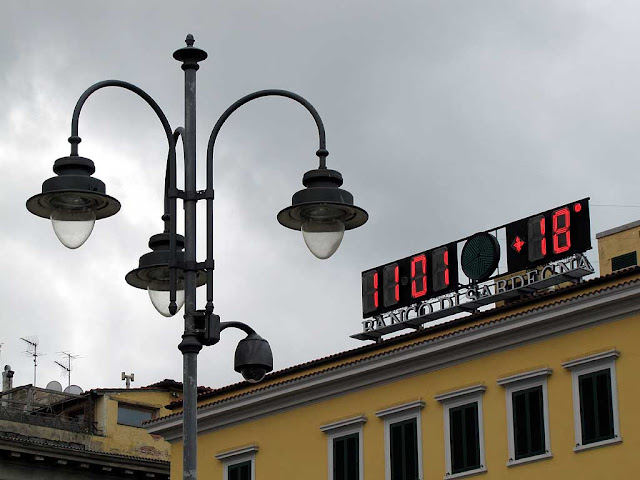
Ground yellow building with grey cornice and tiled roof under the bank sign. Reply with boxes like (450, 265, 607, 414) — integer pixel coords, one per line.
(147, 227, 640, 480)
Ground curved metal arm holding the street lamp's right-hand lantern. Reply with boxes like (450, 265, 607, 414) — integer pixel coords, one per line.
(206, 89, 329, 313)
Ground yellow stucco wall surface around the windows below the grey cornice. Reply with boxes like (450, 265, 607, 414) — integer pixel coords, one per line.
(171, 310, 640, 480)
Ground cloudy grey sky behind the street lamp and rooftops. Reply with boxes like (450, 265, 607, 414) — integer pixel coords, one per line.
(0, 0, 640, 389)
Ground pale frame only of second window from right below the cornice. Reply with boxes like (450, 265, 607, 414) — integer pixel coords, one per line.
(497, 368, 553, 467)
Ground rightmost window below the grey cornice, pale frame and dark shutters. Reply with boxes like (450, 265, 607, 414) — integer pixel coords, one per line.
(562, 350, 622, 451)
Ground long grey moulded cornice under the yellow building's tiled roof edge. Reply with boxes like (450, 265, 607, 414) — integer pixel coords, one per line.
(145, 282, 640, 441)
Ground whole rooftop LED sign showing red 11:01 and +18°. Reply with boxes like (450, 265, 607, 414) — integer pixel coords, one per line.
(362, 198, 591, 318)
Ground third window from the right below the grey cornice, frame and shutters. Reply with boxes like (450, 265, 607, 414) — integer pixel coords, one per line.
(435, 385, 487, 478)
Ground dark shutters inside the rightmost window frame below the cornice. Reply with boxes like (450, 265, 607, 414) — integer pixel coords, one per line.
(578, 368, 614, 444)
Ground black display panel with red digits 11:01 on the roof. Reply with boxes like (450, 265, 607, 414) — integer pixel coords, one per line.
(362, 243, 458, 317)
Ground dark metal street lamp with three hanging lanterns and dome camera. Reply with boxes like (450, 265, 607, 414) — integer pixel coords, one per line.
(27, 35, 368, 480)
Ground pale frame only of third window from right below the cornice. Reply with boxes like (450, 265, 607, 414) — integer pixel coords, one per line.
(435, 385, 487, 479)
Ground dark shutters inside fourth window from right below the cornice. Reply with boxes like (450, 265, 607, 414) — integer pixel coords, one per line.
(389, 418, 418, 480)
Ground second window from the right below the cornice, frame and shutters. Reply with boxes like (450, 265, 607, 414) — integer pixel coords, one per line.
(498, 368, 552, 466)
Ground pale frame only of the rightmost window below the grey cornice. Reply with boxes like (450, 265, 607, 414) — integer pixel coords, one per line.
(562, 349, 622, 452)
